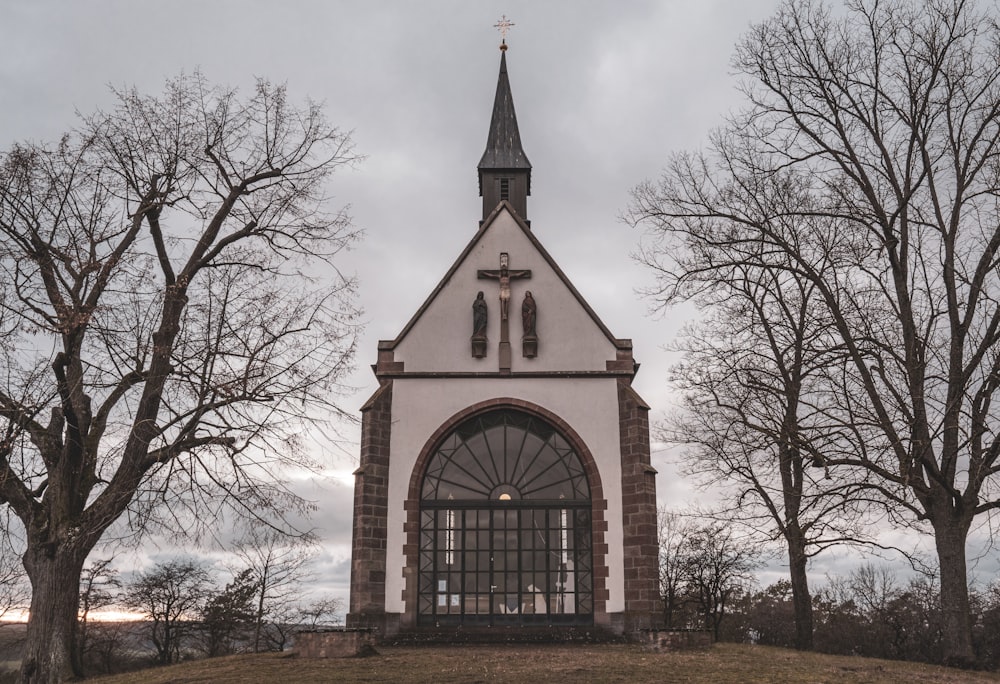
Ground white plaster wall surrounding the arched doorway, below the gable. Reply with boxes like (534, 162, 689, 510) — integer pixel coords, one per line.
(385, 377, 625, 613)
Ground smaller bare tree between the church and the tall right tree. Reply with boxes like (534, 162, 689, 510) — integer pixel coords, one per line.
(664, 254, 884, 649)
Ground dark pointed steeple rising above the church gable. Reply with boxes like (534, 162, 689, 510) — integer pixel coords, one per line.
(479, 39, 531, 219)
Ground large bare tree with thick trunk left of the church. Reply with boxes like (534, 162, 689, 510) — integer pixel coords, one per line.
(0, 75, 356, 682)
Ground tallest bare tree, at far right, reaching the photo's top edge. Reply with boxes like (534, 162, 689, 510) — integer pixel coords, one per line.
(631, 0, 1000, 665)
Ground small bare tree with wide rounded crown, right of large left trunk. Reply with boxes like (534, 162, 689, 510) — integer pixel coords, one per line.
(125, 560, 211, 665)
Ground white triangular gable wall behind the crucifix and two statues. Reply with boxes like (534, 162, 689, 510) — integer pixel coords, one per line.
(395, 211, 615, 373)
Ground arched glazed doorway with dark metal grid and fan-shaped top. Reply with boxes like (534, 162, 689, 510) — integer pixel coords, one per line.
(417, 408, 594, 626)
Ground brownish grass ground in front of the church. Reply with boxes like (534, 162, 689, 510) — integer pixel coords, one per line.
(88, 644, 1000, 684)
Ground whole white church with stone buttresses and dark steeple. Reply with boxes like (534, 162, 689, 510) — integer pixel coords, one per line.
(347, 36, 660, 638)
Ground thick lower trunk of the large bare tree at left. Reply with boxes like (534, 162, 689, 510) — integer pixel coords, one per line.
(21, 542, 87, 684)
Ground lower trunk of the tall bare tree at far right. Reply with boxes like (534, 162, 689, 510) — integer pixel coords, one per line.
(932, 515, 975, 667)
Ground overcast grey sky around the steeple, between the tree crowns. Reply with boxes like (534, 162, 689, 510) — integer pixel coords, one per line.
(9, 0, 944, 596)
